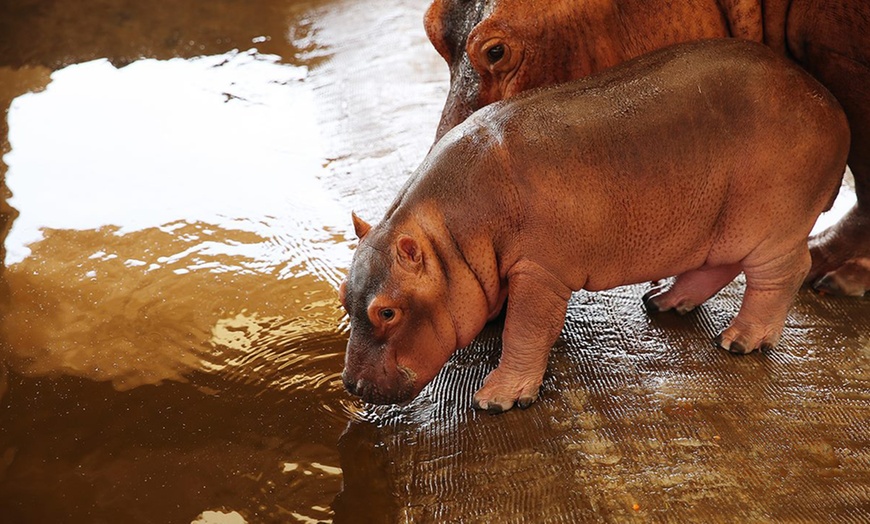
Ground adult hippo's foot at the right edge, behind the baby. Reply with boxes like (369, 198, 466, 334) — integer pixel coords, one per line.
(806, 206, 870, 297)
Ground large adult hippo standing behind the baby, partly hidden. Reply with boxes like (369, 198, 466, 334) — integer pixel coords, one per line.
(425, 0, 870, 296)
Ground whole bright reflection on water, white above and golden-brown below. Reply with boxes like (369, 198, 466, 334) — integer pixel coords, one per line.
(0, 51, 351, 391)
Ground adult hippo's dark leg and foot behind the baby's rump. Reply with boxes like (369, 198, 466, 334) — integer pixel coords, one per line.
(787, 0, 870, 296)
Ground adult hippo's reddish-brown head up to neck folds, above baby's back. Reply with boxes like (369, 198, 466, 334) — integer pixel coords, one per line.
(425, 0, 748, 140)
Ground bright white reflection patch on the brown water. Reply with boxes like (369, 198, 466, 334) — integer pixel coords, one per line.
(5, 51, 348, 264)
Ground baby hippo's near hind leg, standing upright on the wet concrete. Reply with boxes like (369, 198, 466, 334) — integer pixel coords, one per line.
(716, 241, 811, 353)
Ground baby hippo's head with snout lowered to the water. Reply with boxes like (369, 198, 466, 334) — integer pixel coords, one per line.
(339, 215, 456, 404)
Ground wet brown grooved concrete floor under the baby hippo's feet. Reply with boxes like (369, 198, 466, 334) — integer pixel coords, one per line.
(337, 281, 870, 523)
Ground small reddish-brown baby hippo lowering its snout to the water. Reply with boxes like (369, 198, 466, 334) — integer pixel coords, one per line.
(339, 39, 849, 412)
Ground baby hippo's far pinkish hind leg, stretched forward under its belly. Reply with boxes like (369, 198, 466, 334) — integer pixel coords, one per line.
(643, 264, 740, 315)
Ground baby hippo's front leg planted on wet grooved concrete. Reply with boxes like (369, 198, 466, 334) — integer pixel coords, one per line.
(474, 260, 571, 413)
